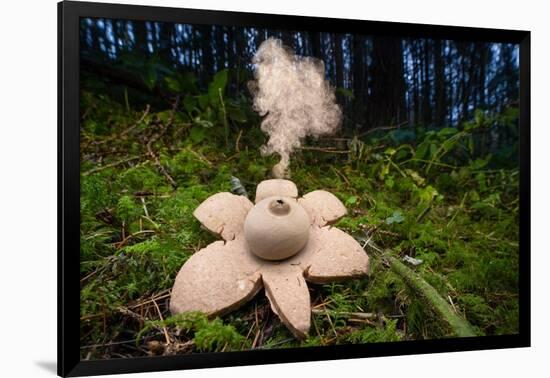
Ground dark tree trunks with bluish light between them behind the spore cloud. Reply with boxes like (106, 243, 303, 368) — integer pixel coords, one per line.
(81, 19, 519, 137)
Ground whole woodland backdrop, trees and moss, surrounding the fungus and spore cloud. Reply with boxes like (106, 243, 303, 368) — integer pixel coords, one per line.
(80, 19, 520, 359)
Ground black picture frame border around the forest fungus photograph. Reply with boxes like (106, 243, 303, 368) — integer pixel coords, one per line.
(58, 1, 531, 376)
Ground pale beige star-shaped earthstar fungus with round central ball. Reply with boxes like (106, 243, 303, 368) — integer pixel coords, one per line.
(170, 179, 369, 338)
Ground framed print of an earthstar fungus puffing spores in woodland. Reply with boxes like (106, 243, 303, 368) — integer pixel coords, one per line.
(58, 1, 530, 376)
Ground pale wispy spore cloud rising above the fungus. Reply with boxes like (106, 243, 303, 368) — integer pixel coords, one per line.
(249, 38, 342, 178)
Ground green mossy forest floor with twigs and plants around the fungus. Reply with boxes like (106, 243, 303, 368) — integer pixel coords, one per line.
(80, 92, 519, 359)
